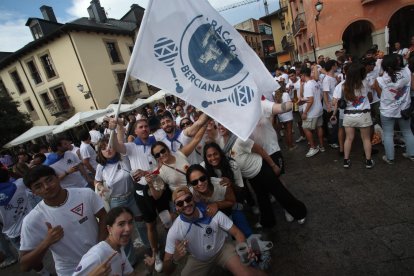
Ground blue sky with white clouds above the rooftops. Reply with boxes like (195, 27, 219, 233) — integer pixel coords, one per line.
(0, 0, 279, 52)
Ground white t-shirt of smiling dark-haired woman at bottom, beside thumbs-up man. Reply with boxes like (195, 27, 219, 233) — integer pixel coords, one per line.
(73, 241, 134, 276)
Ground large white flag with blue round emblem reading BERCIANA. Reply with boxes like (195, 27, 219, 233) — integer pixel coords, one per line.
(128, 0, 279, 140)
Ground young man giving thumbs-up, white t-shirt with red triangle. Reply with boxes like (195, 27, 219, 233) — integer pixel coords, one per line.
(20, 165, 107, 275)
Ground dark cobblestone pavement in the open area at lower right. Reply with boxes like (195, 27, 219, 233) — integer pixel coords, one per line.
(0, 138, 414, 276)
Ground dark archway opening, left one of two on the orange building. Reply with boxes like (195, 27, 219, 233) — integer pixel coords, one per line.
(342, 20, 373, 58)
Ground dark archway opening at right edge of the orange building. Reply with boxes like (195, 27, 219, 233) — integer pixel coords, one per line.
(388, 5, 414, 49)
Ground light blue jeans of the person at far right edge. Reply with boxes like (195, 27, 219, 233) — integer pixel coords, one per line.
(381, 114, 414, 160)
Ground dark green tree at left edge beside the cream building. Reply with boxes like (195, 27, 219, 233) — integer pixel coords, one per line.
(0, 93, 33, 147)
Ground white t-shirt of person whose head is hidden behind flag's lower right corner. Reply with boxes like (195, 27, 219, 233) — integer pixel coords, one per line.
(250, 100, 280, 155)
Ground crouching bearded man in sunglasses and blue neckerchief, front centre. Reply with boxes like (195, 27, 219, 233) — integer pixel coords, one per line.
(164, 186, 265, 276)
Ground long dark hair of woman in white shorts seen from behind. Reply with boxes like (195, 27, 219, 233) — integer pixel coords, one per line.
(344, 63, 367, 102)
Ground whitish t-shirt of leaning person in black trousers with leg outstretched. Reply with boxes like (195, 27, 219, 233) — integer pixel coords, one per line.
(230, 138, 263, 178)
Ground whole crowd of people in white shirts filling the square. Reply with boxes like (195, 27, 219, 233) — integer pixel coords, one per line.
(0, 37, 414, 275)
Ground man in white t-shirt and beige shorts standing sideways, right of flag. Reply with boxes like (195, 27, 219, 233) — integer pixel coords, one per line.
(300, 67, 325, 157)
